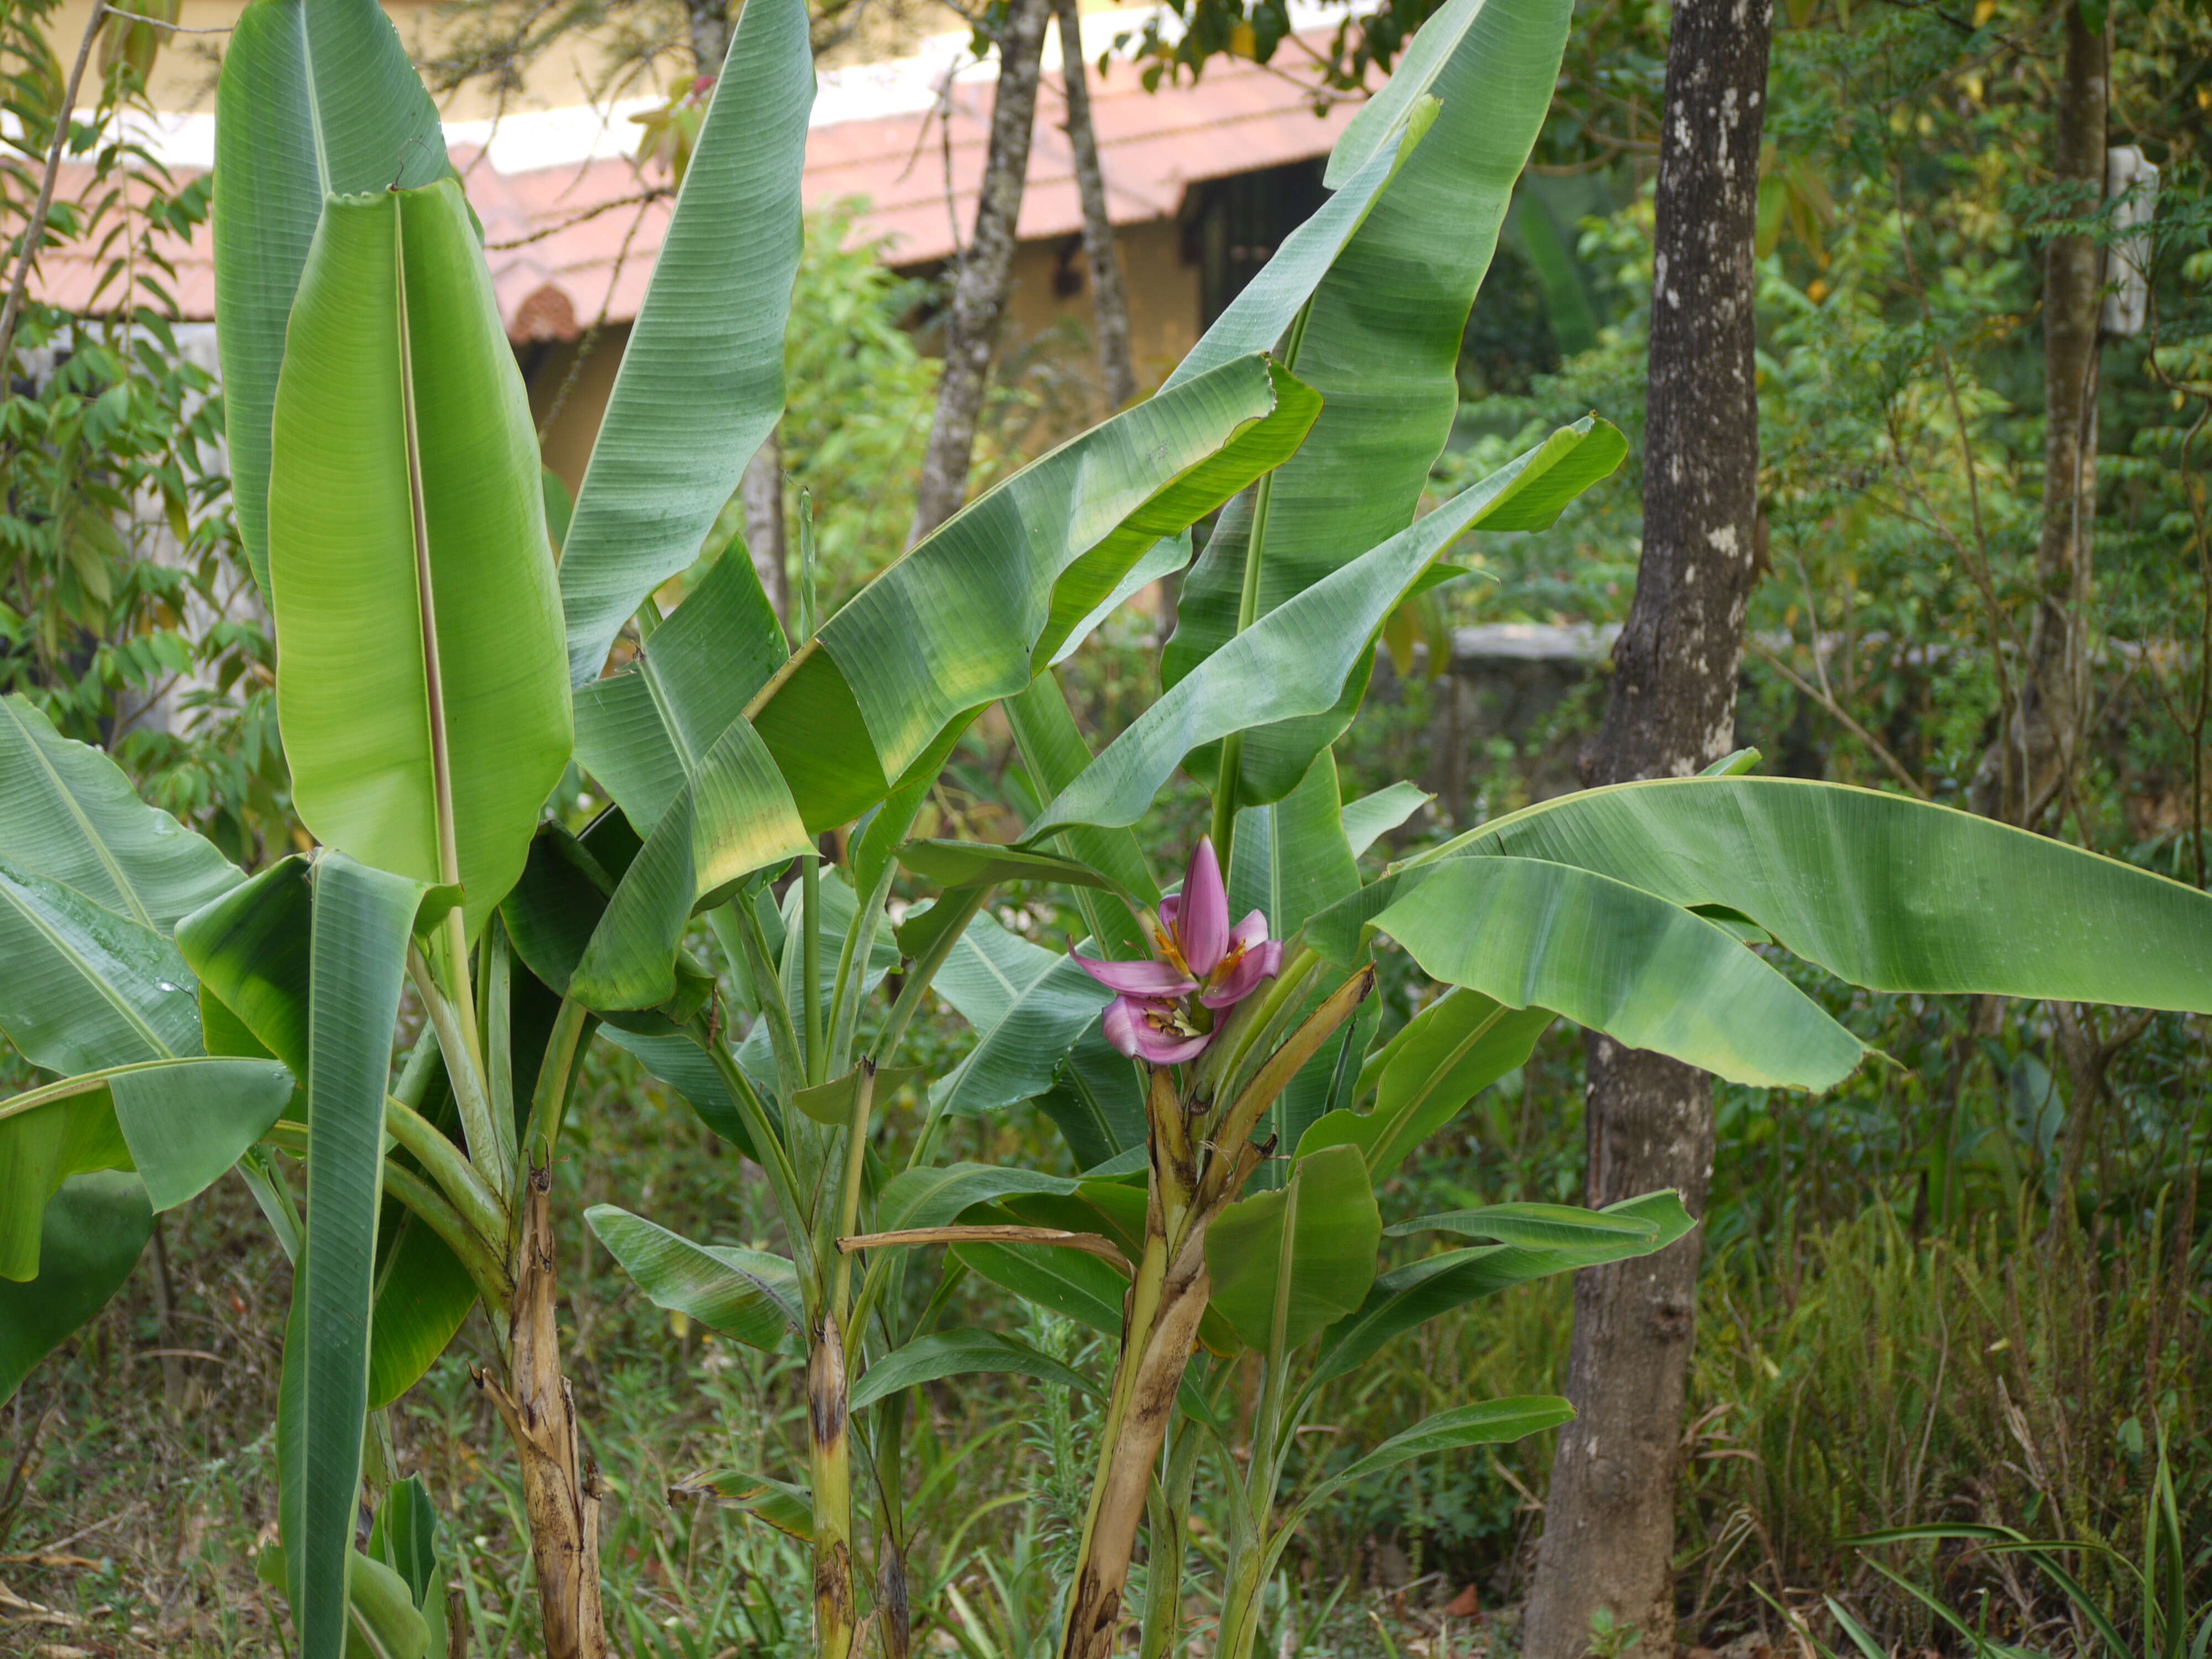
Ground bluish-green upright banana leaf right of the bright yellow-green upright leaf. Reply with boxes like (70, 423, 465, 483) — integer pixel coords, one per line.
(560, 0, 814, 690)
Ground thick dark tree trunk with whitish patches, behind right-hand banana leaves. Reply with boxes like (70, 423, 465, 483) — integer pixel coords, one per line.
(1522, 0, 1772, 1659)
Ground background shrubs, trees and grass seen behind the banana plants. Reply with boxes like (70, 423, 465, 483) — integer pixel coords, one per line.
(0, 0, 2212, 1659)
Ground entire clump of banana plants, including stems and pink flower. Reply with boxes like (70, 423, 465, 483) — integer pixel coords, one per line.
(0, 0, 2212, 1659)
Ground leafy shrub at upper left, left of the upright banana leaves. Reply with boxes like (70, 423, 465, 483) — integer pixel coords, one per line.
(0, 0, 290, 858)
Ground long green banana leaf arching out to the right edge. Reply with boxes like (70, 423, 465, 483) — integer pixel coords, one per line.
(1307, 779, 2212, 1011)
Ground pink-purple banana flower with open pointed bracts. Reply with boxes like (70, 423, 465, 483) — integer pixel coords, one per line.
(1075, 836, 1283, 1066)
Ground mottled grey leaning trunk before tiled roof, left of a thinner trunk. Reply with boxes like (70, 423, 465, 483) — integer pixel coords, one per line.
(907, 0, 1048, 544)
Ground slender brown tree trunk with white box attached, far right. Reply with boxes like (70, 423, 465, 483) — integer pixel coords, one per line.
(1973, 4, 2110, 827)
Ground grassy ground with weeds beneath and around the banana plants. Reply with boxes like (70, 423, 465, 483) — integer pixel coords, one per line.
(0, 1037, 2212, 1659)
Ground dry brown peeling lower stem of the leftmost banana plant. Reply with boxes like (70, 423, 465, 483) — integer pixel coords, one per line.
(478, 1168, 606, 1659)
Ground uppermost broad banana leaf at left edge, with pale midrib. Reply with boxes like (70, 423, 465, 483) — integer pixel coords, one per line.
(0, 697, 239, 931)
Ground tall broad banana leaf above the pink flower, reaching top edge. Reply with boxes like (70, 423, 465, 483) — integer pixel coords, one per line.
(1161, 0, 1573, 801)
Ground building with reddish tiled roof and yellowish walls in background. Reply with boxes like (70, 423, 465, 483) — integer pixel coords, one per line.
(30, 0, 1354, 487)
